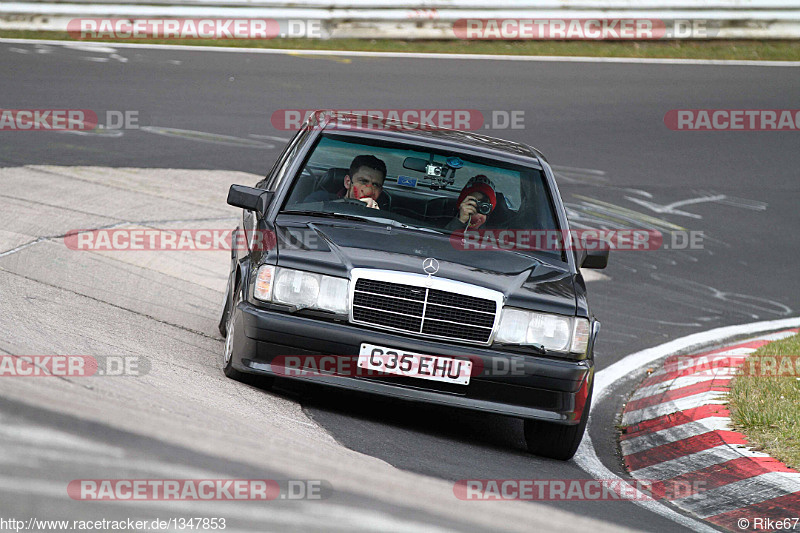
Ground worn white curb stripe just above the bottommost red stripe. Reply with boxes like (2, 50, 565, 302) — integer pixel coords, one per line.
(672, 472, 800, 518)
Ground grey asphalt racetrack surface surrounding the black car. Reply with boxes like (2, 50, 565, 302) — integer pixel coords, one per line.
(0, 43, 800, 531)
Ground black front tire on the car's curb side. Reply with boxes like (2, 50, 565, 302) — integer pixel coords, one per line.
(525, 386, 594, 461)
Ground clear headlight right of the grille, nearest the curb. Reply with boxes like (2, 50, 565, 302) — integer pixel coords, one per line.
(494, 307, 590, 354)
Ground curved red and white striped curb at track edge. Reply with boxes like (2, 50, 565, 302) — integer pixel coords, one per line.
(620, 329, 800, 531)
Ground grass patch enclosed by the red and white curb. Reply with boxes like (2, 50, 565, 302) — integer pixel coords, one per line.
(729, 335, 800, 468)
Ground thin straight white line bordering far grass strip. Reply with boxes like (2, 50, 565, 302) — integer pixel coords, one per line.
(0, 39, 800, 68)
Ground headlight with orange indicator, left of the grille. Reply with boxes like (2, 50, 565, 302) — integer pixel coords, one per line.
(253, 265, 350, 314)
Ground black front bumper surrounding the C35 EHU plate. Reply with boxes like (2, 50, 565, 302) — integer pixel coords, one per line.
(232, 302, 594, 424)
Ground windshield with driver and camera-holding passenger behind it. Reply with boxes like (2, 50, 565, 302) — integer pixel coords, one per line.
(282, 135, 561, 255)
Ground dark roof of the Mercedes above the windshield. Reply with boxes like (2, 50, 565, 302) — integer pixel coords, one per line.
(310, 110, 546, 166)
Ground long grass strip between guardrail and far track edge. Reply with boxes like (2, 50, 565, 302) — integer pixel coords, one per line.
(0, 30, 800, 61)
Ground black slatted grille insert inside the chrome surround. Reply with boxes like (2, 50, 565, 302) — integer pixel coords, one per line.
(353, 277, 498, 344)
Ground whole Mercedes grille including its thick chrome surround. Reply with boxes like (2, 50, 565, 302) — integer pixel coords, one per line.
(350, 269, 502, 345)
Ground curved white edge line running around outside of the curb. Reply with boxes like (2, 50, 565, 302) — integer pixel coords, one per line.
(574, 317, 800, 533)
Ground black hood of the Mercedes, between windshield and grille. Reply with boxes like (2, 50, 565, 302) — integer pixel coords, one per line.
(275, 219, 576, 315)
